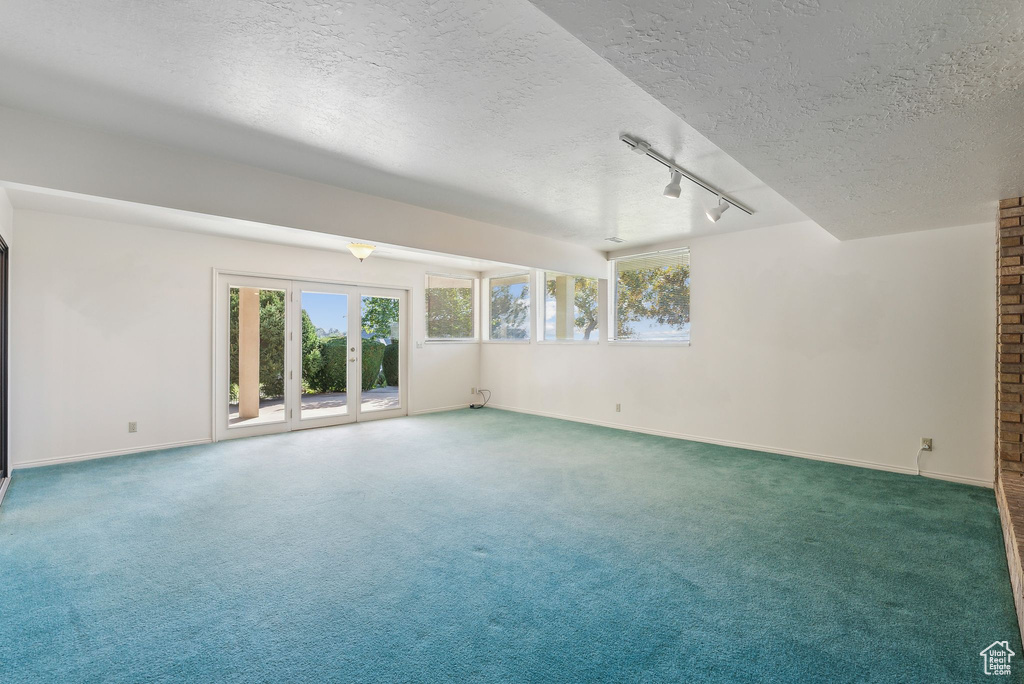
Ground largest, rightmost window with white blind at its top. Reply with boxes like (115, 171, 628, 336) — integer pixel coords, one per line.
(613, 249, 690, 344)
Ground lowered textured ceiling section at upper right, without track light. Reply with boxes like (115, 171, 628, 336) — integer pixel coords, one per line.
(531, 0, 1024, 239)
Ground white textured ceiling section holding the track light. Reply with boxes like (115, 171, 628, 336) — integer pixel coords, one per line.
(0, 0, 806, 249)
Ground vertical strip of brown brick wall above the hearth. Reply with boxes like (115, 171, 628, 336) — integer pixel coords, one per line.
(995, 198, 1024, 477)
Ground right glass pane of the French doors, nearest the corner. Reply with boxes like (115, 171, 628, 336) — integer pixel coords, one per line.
(359, 296, 401, 411)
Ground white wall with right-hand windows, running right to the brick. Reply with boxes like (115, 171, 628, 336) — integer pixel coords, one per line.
(480, 223, 995, 484)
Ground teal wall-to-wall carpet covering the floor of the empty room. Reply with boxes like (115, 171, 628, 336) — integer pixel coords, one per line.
(0, 410, 1024, 682)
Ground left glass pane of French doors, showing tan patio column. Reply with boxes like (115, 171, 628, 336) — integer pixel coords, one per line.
(227, 287, 285, 427)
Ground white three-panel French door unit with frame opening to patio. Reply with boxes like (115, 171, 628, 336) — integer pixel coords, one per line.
(214, 273, 409, 439)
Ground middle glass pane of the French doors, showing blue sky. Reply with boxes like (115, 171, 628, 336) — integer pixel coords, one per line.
(299, 292, 349, 419)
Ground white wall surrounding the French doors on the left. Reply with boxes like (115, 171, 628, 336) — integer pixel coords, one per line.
(10, 210, 479, 468)
